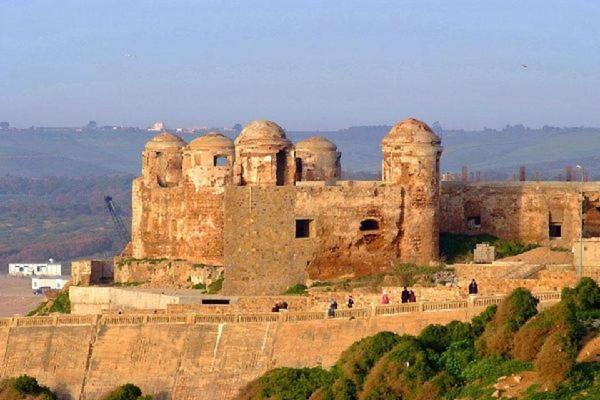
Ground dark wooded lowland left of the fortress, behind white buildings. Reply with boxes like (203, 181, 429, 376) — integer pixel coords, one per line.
(0, 176, 133, 272)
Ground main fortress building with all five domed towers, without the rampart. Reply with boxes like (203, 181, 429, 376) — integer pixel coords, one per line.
(131, 119, 441, 294)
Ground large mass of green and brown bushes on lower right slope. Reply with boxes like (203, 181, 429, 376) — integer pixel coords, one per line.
(241, 278, 600, 400)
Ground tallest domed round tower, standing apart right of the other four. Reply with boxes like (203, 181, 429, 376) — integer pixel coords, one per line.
(381, 118, 442, 264)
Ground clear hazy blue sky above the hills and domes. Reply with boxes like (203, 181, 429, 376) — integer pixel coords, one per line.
(0, 0, 600, 130)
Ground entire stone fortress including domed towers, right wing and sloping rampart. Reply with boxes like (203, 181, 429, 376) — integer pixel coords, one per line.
(5, 119, 600, 400)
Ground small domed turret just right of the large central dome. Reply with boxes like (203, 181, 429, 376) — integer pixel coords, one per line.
(296, 136, 342, 181)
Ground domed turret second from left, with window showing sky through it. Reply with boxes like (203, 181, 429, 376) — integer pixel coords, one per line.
(183, 132, 235, 187)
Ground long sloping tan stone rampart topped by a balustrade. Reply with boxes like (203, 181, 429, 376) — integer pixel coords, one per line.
(0, 293, 560, 400)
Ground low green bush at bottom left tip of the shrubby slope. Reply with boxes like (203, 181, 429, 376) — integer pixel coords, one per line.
(239, 367, 331, 400)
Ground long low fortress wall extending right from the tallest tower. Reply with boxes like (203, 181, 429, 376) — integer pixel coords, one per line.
(440, 182, 584, 247)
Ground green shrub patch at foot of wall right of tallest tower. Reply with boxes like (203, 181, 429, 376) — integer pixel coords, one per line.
(440, 233, 539, 264)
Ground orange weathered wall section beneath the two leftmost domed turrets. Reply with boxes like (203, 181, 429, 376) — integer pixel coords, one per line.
(131, 178, 223, 265)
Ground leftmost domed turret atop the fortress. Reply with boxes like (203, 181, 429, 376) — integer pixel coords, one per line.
(142, 132, 185, 187)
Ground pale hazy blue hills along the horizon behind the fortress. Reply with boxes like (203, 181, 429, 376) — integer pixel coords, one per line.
(0, 125, 600, 179)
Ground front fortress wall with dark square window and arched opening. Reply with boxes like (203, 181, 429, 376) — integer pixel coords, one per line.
(224, 182, 424, 295)
